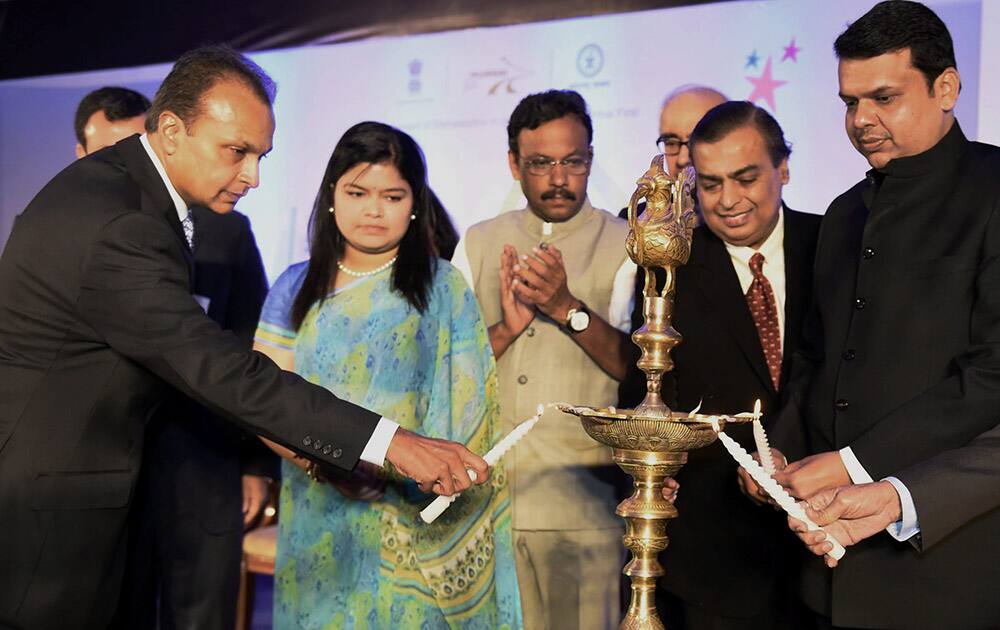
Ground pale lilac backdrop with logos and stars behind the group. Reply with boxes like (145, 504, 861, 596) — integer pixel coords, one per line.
(0, 0, 1000, 280)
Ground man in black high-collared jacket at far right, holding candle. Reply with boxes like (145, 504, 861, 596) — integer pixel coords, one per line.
(744, 1, 1000, 628)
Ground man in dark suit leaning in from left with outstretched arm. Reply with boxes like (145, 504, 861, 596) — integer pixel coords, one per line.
(0, 47, 487, 630)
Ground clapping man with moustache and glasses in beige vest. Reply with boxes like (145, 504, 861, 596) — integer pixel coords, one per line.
(453, 91, 635, 630)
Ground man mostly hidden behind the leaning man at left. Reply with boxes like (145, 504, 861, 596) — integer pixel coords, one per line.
(75, 87, 276, 630)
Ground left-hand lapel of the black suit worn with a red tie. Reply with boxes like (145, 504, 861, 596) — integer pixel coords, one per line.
(681, 226, 774, 392)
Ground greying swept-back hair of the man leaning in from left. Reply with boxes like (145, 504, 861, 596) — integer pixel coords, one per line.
(146, 45, 277, 132)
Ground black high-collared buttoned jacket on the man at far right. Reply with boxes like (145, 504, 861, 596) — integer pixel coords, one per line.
(777, 123, 1000, 628)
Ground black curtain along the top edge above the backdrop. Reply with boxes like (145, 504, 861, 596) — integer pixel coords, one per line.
(0, 0, 718, 79)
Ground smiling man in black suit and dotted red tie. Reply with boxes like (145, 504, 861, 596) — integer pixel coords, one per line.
(621, 101, 820, 630)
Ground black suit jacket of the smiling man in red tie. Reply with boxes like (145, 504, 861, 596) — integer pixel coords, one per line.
(620, 209, 820, 617)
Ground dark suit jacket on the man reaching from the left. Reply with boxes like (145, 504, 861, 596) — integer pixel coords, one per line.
(0, 136, 378, 629)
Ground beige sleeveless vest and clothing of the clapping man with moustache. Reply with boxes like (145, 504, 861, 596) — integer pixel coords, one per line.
(464, 202, 628, 628)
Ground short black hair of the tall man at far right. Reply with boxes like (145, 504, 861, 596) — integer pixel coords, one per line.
(833, 0, 958, 92)
